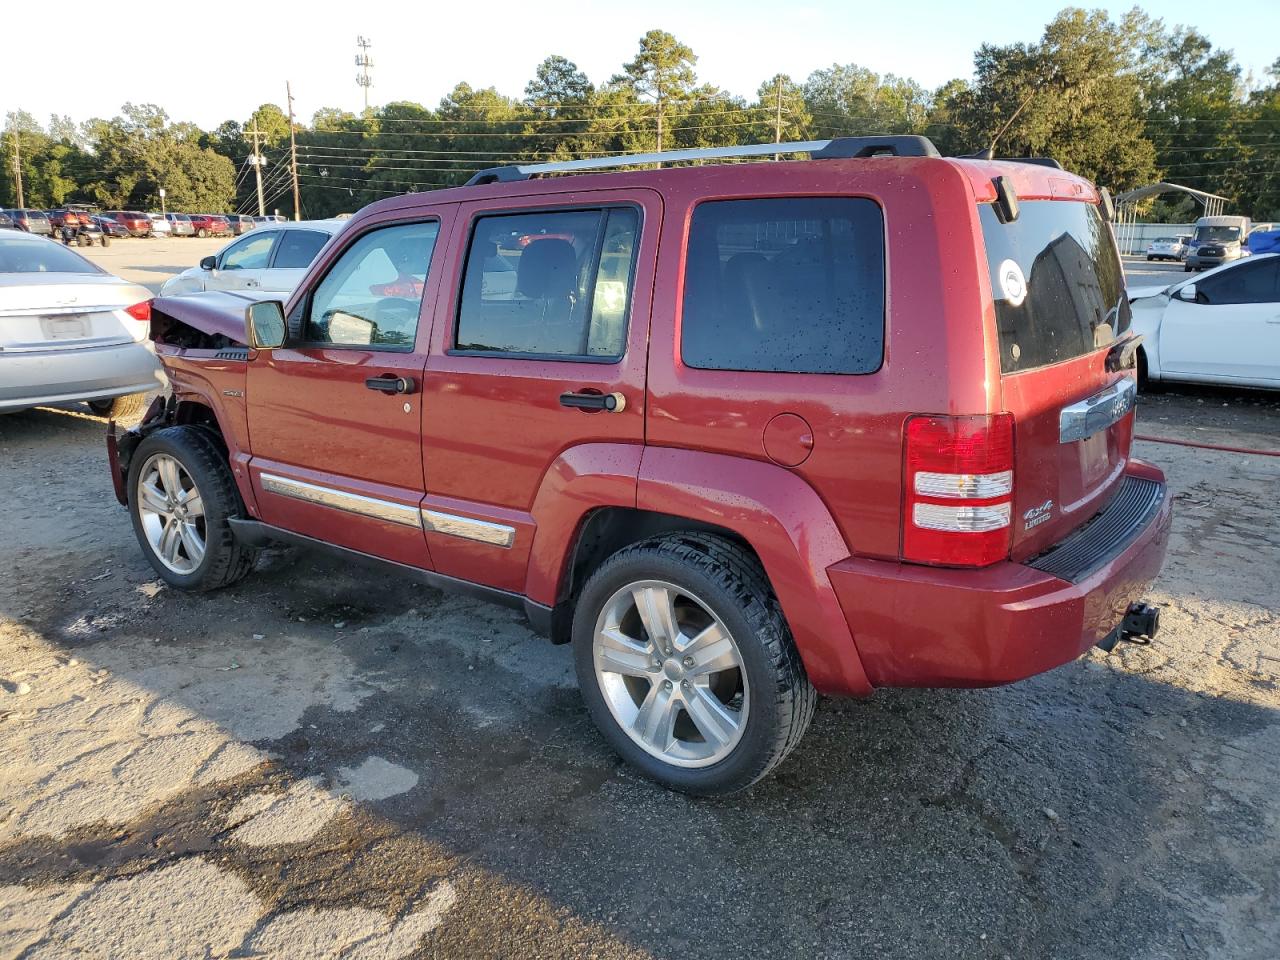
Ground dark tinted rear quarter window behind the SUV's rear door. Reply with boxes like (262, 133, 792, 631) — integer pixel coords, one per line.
(681, 197, 884, 374)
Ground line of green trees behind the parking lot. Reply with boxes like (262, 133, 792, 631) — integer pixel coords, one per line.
(0, 19, 1280, 219)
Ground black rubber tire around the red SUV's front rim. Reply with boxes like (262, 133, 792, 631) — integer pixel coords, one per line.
(127, 426, 259, 591)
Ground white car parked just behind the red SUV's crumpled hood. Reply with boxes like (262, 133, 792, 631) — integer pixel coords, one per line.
(160, 220, 344, 297)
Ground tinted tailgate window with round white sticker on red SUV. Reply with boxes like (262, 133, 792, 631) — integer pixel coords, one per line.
(978, 200, 1129, 374)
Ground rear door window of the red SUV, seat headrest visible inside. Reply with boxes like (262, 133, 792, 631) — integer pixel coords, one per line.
(454, 207, 640, 360)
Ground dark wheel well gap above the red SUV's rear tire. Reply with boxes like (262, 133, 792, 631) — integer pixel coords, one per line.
(550, 507, 763, 644)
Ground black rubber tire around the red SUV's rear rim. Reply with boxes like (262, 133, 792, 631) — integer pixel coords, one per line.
(572, 532, 817, 796)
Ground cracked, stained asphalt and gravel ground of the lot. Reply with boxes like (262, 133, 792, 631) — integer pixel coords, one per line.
(0, 239, 1280, 960)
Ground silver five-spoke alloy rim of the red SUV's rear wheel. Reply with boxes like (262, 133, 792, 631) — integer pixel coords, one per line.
(593, 580, 750, 767)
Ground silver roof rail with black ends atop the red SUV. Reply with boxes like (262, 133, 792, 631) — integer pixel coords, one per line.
(466, 134, 941, 187)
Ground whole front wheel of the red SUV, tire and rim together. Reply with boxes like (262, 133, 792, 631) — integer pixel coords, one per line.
(128, 426, 257, 590)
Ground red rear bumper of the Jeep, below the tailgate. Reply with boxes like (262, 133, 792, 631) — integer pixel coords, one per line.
(827, 461, 1172, 687)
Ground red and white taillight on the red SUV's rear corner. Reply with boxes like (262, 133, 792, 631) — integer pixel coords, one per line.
(902, 413, 1014, 567)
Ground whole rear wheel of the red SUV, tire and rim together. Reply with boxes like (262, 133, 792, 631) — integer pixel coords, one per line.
(573, 532, 817, 796)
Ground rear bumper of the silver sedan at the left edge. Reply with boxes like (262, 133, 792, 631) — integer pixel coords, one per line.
(0, 343, 163, 411)
